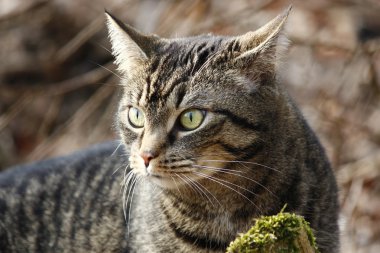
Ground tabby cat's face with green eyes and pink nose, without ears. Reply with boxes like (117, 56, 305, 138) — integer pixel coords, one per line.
(118, 41, 257, 187)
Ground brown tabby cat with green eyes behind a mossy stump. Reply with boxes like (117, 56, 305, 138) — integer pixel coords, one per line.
(0, 8, 339, 252)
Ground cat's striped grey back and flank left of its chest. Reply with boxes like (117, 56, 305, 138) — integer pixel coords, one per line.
(0, 143, 126, 253)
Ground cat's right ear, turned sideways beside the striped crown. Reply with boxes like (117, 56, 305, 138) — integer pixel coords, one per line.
(234, 6, 292, 78)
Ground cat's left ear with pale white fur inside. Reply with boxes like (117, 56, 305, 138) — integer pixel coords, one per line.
(105, 11, 158, 74)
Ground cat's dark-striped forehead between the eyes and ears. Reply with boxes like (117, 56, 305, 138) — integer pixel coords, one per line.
(126, 36, 229, 107)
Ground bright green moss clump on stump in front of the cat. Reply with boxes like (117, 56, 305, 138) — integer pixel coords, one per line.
(227, 211, 319, 253)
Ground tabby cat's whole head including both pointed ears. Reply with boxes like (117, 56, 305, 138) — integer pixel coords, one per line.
(106, 8, 290, 188)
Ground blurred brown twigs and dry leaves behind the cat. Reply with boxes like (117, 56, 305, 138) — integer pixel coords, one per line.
(0, 0, 380, 253)
